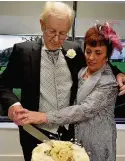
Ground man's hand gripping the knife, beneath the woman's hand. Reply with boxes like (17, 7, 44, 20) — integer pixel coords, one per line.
(8, 105, 28, 125)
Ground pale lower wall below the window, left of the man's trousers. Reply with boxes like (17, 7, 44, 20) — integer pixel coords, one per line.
(0, 123, 24, 161)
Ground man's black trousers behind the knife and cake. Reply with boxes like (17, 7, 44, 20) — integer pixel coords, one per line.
(19, 126, 74, 161)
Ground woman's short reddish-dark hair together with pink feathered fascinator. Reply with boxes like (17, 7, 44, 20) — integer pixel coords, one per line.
(84, 23, 122, 58)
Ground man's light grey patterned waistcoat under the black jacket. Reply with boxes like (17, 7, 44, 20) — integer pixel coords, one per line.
(37, 49, 72, 133)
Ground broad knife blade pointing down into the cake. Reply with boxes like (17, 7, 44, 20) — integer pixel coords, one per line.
(23, 124, 50, 142)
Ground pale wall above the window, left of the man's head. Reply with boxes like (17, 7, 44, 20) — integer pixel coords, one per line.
(0, 1, 72, 34)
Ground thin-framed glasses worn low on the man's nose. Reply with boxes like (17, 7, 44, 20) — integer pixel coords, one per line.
(45, 29, 67, 40)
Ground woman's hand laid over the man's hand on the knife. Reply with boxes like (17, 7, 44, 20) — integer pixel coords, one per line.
(18, 111, 48, 125)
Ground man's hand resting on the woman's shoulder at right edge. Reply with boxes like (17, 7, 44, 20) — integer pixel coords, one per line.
(117, 73, 125, 96)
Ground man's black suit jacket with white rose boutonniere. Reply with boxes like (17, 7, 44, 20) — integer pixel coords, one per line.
(0, 39, 85, 111)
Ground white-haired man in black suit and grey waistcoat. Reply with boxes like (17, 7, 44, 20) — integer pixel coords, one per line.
(0, 2, 124, 161)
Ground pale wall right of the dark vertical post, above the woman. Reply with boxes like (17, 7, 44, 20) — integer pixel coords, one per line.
(76, 1, 125, 38)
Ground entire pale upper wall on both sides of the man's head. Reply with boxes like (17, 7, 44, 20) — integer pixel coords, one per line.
(0, 1, 125, 38)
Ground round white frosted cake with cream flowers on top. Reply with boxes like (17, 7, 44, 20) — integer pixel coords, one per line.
(31, 140, 90, 161)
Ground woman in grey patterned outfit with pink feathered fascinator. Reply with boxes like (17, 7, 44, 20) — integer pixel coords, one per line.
(18, 23, 122, 161)
